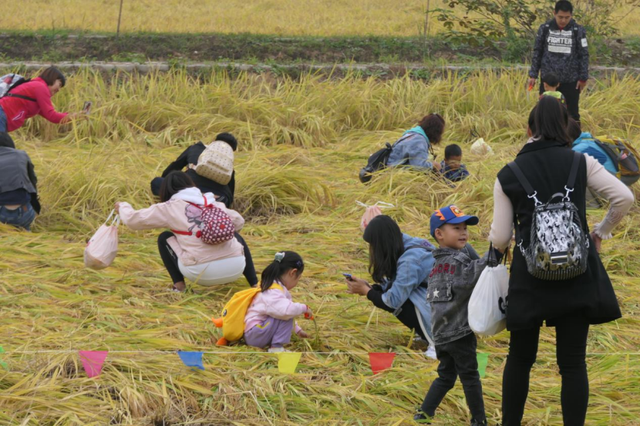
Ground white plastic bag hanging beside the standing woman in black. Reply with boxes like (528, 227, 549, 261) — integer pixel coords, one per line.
(469, 264, 509, 336)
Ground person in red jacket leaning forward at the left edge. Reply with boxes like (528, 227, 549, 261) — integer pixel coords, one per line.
(0, 67, 86, 132)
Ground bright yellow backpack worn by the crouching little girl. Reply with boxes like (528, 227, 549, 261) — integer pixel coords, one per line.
(211, 283, 284, 346)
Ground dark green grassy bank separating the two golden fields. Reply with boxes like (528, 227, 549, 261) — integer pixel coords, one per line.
(0, 29, 640, 68)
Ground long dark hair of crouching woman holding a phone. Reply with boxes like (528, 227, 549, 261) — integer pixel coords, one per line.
(362, 215, 404, 283)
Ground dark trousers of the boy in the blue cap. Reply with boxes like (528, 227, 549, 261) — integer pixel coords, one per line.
(421, 333, 486, 421)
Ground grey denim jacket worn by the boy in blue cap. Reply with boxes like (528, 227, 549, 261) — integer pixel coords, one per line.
(427, 248, 487, 345)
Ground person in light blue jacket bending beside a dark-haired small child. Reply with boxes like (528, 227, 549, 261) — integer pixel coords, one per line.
(387, 114, 445, 172)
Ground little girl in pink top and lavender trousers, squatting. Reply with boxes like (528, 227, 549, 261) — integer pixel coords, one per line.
(244, 251, 311, 352)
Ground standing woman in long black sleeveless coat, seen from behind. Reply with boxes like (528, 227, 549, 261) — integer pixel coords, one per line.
(490, 97, 633, 426)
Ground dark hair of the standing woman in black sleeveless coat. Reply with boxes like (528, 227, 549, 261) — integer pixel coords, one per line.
(533, 96, 573, 145)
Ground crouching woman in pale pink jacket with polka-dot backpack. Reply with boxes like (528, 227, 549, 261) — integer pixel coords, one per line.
(116, 172, 245, 292)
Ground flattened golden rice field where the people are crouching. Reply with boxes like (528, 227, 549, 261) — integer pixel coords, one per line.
(0, 68, 640, 426)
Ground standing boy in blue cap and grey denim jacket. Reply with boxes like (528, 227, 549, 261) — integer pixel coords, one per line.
(414, 205, 496, 426)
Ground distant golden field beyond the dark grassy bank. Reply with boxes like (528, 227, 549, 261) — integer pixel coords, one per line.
(1, 0, 640, 36)
